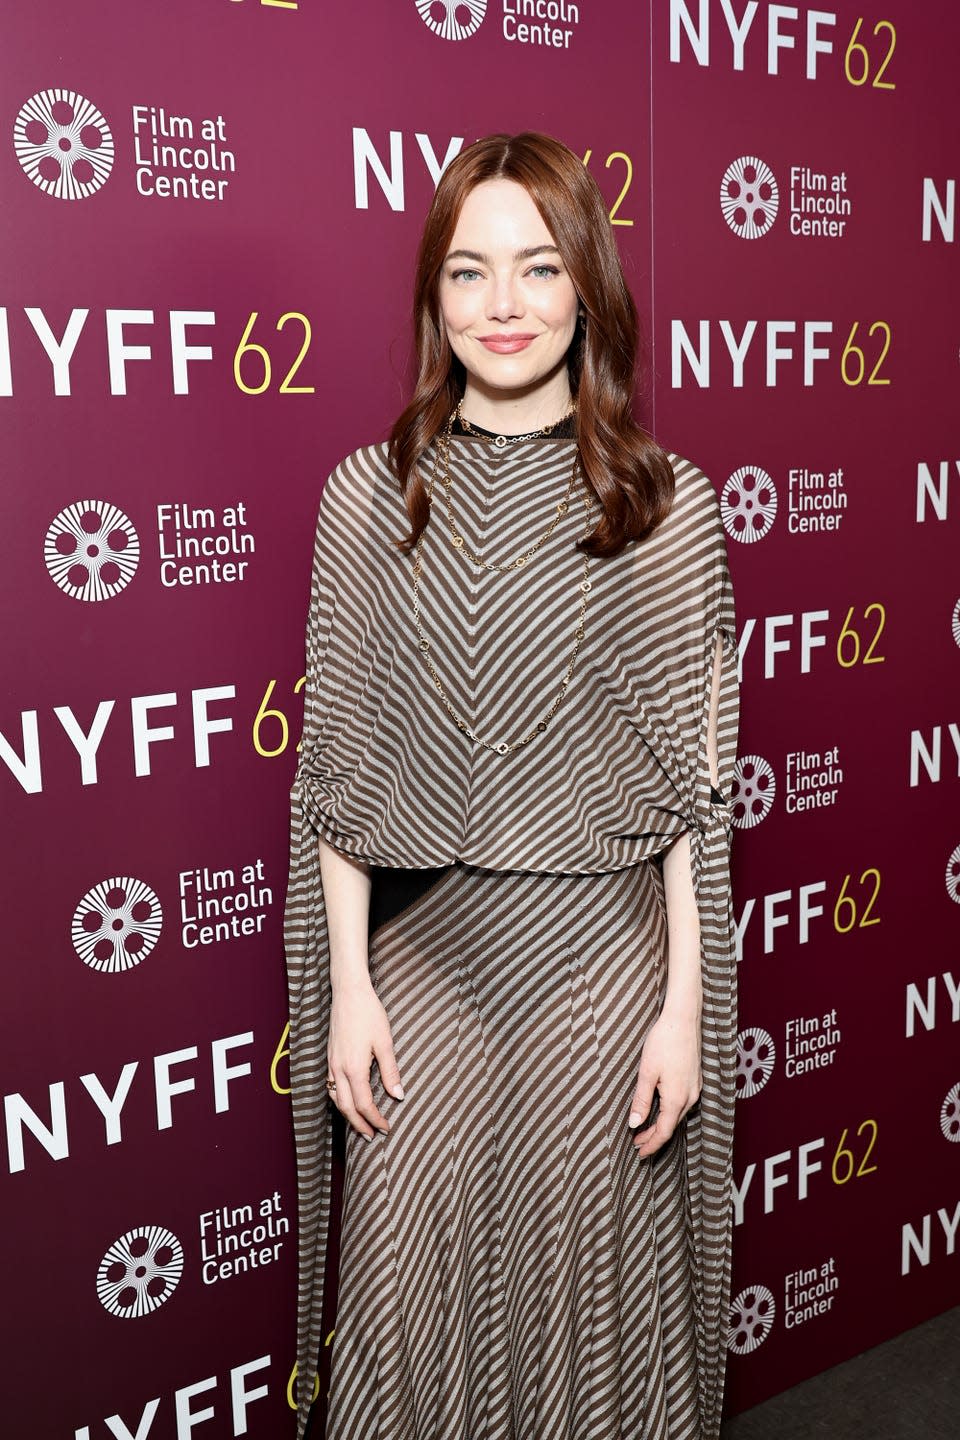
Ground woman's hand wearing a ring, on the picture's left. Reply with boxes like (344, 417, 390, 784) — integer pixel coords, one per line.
(327, 975, 403, 1140)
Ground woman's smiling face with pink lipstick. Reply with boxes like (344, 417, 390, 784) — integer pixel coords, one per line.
(439, 180, 579, 397)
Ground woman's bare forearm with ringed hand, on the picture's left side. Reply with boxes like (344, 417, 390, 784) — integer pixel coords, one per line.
(318, 837, 403, 1140)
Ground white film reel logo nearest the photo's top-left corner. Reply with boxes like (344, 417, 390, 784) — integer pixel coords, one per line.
(13, 89, 114, 200)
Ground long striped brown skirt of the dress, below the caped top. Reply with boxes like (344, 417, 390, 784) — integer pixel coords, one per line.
(327, 861, 701, 1440)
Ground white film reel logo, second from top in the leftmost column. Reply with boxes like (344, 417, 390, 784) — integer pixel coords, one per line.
(43, 500, 140, 600)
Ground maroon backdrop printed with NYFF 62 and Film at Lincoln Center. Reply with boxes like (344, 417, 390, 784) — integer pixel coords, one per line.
(0, 0, 960, 1440)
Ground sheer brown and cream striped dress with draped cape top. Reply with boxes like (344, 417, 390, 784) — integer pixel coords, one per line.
(284, 435, 737, 1440)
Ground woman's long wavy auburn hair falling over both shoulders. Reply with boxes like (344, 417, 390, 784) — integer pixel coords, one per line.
(389, 131, 674, 556)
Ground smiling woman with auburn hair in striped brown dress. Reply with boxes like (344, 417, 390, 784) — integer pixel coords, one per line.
(285, 134, 737, 1440)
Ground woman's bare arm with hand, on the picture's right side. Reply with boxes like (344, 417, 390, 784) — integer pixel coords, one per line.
(629, 639, 723, 1155)
